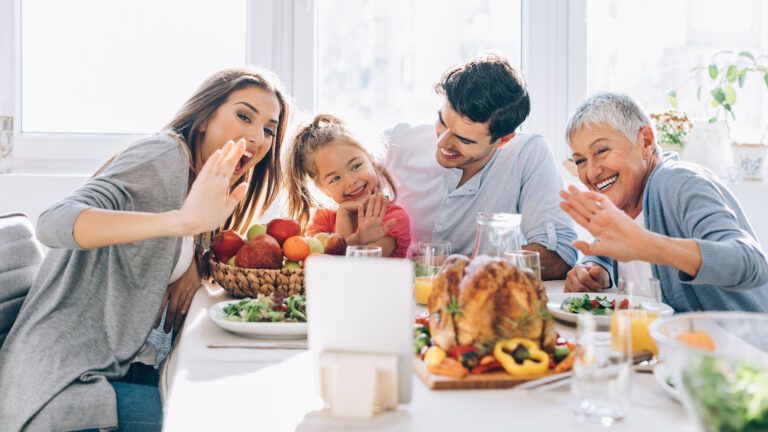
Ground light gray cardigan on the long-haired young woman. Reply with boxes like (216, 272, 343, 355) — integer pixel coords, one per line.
(0, 135, 189, 431)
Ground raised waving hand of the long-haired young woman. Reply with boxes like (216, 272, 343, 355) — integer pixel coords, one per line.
(179, 139, 248, 235)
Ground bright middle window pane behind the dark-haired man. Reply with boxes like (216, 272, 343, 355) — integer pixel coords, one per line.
(317, 0, 522, 127)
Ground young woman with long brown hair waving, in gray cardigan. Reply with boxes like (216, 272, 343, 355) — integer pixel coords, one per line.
(0, 69, 288, 431)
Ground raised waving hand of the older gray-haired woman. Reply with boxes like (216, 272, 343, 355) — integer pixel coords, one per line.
(560, 186, 654, 261)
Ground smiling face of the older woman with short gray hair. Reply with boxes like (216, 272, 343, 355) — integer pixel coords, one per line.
(571, 126, 658, 218)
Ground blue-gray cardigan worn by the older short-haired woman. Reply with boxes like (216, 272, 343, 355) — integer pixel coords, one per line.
(583, 153, 768, 312)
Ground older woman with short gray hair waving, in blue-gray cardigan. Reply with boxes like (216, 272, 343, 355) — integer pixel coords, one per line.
(560, 93, 768, 312)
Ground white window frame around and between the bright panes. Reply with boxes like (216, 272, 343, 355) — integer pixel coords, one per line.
(0, 0, 587, 173)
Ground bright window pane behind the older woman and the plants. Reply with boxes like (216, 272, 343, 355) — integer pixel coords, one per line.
(587, 0, 768, 141)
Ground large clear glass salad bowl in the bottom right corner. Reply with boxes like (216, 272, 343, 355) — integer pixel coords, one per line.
(650, 312, 768, 432)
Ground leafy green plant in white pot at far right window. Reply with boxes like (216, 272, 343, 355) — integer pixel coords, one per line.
(667, 51, 768, 180)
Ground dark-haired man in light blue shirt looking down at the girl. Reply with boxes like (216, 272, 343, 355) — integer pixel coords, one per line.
(385, 55, 577, 279)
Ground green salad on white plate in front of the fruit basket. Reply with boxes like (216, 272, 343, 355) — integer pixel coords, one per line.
(224, 294, 307, 322)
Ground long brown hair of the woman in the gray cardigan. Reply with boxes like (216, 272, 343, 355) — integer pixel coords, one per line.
(164, 68, 290, 231)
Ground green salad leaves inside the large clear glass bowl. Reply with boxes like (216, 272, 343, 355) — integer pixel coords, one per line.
(682, 356, 768, 432)
